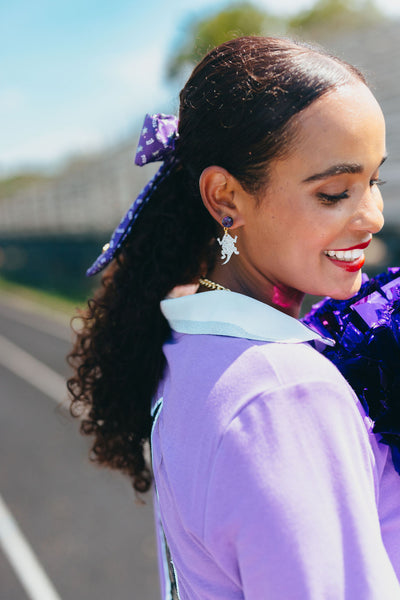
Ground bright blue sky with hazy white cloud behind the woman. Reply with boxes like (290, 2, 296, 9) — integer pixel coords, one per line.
(0, 0, 400, 177)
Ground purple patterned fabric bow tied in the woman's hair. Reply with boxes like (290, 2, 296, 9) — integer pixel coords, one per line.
(86, 114, 178, 277)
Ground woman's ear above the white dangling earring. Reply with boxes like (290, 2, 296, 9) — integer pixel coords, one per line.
(199, 166, 245, 229)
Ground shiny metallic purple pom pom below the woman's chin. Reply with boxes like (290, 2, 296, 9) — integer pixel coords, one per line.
(303, 268, 400, 475)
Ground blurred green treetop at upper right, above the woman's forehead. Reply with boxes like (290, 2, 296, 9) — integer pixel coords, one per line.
(288, 0, 383, 34)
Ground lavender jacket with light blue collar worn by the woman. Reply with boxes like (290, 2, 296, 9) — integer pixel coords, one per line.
(151, 291, 400, 600)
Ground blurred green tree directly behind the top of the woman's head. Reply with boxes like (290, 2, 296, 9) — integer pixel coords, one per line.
(167, 2, 283, 79)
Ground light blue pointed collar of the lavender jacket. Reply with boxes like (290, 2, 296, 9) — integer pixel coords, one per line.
(161, 290, 334, 346)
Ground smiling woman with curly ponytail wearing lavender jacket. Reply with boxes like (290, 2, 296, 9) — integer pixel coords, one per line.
(69, 37, 400, 600)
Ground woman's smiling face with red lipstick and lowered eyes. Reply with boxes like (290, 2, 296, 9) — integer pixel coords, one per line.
(231, 82, 386, 312)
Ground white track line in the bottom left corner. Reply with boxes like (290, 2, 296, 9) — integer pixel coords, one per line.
(0, 496, 61, 600)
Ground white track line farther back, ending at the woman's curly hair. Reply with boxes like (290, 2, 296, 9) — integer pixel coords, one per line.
(0, 335, 67, 405)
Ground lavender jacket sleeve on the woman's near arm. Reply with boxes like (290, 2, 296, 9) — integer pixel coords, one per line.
(204, 382, 400, 600)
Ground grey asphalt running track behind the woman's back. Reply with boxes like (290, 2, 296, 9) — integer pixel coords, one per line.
(0, 298, 159, 600)
